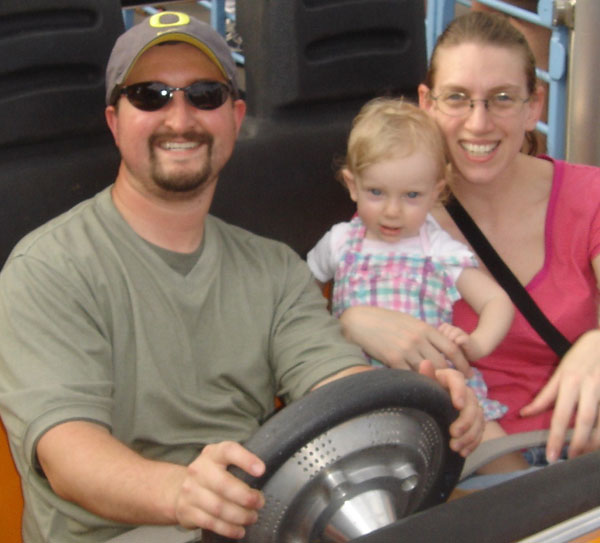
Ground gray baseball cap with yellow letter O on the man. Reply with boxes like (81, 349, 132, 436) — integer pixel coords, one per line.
(106, 11, 239, 105)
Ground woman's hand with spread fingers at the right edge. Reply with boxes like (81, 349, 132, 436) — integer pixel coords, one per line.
(521, 330, 600, 462)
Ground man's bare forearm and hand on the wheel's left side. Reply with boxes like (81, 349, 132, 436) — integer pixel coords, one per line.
(37, 421, 265, 538)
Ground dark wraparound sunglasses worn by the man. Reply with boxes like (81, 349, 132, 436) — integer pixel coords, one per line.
(119, 81, 233, 111)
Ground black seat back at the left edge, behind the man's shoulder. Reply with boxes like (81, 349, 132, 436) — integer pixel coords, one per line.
(0, 0, 123, 265)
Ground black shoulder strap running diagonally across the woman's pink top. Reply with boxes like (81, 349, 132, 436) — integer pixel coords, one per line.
(446, 196, 571, 357)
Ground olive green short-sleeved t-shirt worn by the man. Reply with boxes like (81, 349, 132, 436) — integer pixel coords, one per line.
(0, 188, 364, 543)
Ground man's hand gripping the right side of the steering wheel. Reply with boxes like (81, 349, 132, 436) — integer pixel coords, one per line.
(419, 360, 485, 458)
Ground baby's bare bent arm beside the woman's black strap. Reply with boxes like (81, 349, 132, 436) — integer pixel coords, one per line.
(456, 268, 515, 361)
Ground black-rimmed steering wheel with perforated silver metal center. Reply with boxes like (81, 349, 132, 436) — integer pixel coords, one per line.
(202, 368, 464, 543)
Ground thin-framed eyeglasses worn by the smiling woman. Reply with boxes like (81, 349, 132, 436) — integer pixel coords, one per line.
(429, 91, 530, 117)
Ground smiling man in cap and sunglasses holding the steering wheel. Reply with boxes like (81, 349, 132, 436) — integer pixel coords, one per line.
(0, 12, 482, 543)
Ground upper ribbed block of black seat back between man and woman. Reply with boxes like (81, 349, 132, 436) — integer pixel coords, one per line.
(236, 0, 426, 117)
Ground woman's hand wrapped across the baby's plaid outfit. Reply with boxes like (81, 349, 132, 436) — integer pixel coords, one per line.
(340, 306, 471, 377)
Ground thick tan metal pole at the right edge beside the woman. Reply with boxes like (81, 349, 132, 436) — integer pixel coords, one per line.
(566, 0, 600, 166)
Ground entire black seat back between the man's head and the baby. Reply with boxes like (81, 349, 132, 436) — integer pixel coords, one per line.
(213, 0, 426, 256)
